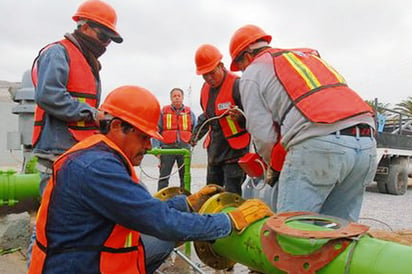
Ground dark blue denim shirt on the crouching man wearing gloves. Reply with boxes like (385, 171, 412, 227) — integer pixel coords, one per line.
(45, 144, 232, 273)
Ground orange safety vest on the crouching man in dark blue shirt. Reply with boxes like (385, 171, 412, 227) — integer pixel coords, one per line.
(29, 134, 146, 274)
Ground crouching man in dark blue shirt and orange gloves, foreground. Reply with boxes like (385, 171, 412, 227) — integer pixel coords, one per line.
(29, 86, 273, 273)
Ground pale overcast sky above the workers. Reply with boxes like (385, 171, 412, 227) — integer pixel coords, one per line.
(0, 0, 412, 114)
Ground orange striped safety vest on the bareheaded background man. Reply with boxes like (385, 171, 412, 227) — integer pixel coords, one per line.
(162, 105, 192, 144)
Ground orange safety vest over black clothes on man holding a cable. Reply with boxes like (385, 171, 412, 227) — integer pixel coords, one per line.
(200, 71, 250, 149)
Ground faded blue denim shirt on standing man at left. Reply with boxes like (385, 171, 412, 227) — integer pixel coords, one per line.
(34, 44, 101, 155)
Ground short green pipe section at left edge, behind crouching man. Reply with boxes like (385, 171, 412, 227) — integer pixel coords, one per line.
(0, 170, 40, 206)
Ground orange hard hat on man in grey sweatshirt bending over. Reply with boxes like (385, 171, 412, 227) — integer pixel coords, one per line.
(229, 25, 272, 71)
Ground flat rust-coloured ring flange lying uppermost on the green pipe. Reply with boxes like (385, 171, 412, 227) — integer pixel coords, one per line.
(266, 212, 369, 239)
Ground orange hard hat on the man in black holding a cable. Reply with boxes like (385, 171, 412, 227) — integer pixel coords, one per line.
(195, 44, 223, 75)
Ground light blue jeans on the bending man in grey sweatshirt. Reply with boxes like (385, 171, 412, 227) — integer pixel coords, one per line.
(277, 134, 377, 221)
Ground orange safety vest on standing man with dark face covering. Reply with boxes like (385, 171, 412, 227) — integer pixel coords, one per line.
(32, 39, 98, 146)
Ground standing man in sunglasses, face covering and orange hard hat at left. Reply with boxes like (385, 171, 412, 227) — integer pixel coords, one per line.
(27, 0, 123, 263)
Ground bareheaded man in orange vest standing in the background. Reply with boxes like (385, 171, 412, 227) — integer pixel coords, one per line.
(153, 88, 196, 190)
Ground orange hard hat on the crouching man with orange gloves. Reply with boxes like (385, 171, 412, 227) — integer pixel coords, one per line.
(100, 86, 163, 141)
